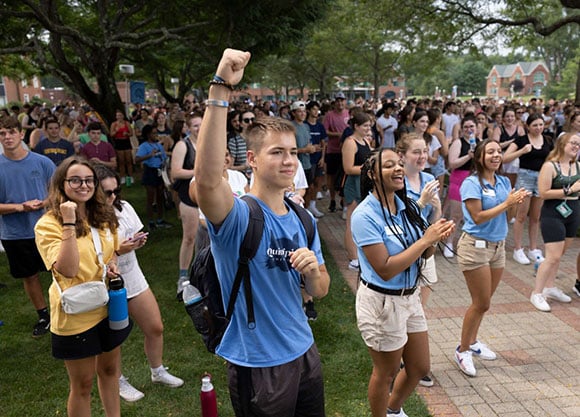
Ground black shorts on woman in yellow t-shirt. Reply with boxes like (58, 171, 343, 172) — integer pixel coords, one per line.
(51, 318, 133, 360)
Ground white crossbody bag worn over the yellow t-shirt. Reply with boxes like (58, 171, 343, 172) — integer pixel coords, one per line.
(52, 227, 109, 314)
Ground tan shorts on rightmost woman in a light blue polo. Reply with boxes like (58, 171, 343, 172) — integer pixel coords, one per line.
(457, 232, 505, 272)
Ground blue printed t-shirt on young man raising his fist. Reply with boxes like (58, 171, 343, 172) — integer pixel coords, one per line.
(208, 194, 324, 368)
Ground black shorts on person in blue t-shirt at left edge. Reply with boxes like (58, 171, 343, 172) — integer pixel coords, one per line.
(2, 239, 46, 278)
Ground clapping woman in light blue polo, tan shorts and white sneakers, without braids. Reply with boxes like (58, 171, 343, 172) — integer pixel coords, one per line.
(454, 139, 529, 376)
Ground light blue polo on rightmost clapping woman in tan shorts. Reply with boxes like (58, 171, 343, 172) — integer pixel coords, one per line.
(459, 175, 512, 242)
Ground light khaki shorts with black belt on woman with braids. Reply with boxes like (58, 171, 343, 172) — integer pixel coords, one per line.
(356, 284, 427, 352)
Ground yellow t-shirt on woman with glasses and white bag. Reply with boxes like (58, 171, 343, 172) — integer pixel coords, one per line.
(34, 213, 117, 336)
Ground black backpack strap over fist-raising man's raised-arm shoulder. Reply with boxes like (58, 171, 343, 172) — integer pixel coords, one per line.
(226, 196, 264, 329)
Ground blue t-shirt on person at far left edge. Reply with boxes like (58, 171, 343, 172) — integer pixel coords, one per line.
(0, 152, 56, 240)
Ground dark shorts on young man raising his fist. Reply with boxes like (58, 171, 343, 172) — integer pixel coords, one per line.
(228, 344, 325, 417)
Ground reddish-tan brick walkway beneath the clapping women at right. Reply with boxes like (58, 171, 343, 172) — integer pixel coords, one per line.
(318, 200, 580, 417)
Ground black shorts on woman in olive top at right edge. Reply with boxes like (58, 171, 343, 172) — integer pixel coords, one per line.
(540, 200, 580, 243)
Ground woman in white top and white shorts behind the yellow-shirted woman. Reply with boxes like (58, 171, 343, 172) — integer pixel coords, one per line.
(95, 165, 183, 402)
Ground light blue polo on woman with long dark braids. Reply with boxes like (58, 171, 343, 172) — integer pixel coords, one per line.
(351, 194, 423, 290)
